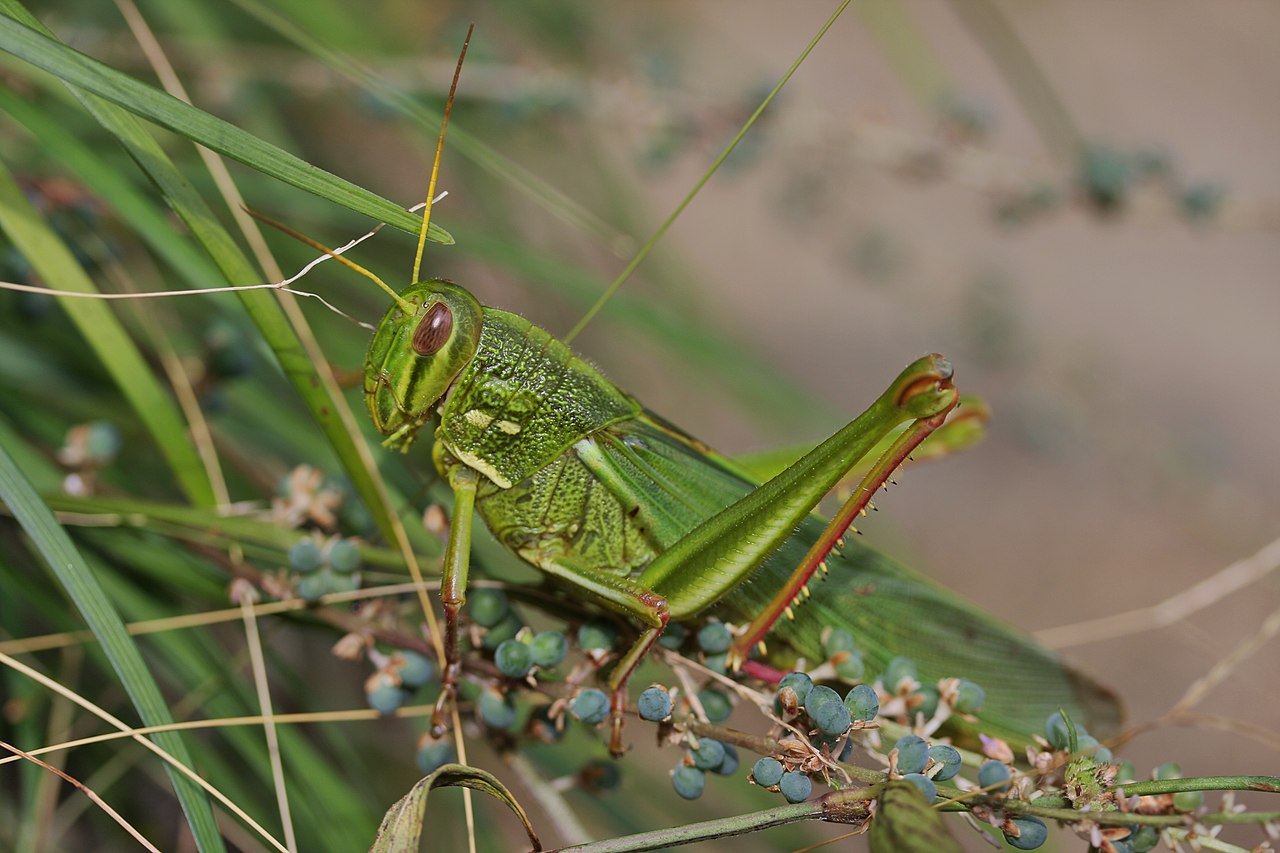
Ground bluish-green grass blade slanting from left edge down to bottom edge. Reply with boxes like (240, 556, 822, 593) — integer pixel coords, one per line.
(0, 435, 225, 852)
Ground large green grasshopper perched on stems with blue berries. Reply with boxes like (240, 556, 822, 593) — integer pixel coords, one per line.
(365, 279, 1119, 752)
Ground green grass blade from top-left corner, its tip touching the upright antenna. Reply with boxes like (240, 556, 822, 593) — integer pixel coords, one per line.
(0, 10, 453, 245)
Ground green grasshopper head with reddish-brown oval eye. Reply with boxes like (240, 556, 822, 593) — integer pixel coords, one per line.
(365, 279, 483, 450)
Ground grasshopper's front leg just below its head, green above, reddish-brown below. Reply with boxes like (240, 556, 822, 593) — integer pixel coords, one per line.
(431, 465, 480, 738)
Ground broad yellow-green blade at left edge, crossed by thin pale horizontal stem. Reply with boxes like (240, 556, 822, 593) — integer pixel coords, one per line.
(0, 157, 215, 506)
